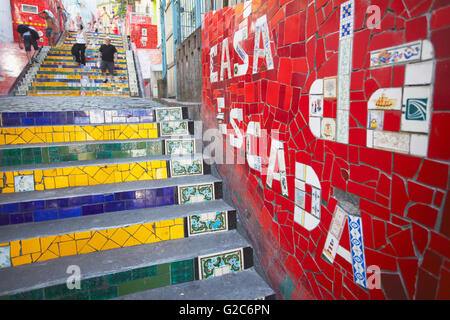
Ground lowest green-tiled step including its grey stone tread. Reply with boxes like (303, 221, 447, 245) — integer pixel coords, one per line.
(0, 230, 253, 299)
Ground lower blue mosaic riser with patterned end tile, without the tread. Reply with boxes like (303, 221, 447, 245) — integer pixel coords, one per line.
(0, 182, 222, 225)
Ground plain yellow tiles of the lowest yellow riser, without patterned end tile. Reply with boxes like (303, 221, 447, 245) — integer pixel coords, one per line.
(0, 218, 185, 267)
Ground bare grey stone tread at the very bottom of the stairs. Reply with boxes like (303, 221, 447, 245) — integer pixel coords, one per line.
(113, 268, 275, 300)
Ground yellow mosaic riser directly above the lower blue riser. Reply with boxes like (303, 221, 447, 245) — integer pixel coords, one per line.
(0, 157, 210, 193)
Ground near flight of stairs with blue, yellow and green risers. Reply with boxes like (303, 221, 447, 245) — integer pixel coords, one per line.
(0, 94, 274, 300)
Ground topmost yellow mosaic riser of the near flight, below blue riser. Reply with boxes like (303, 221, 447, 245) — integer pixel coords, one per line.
(0, 121, 195, 145)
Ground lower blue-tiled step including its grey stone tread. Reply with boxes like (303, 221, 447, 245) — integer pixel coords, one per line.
(0, 175, 222, 225)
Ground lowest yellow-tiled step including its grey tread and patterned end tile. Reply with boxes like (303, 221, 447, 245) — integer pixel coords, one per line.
(0, 201, 236, 268)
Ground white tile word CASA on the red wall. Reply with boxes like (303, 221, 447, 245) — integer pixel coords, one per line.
(209, 15, 274, 83)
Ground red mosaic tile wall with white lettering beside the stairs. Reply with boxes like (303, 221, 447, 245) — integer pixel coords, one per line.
(202, 0, 450, 300)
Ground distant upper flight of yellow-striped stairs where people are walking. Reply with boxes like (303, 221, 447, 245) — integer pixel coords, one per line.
(16, 32, 139, 97)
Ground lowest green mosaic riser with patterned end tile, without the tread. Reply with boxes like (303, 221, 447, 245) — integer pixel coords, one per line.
(0, 247, 253, 300)
